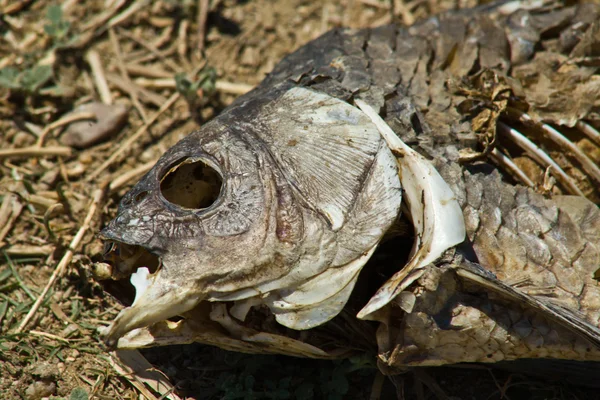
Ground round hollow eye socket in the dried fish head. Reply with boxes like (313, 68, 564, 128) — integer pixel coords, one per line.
(160, 160, 223, 209)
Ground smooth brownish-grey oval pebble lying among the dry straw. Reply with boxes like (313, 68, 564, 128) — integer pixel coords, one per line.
(59, 103, 129, 149)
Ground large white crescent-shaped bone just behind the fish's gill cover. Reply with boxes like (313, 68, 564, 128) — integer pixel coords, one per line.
(355, 99, 466, 319)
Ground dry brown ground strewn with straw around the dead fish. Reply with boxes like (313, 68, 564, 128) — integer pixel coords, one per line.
(0, 0, 594, 400)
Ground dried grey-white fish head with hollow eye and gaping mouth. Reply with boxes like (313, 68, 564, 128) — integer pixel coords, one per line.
(101, 88, 401, 345)
